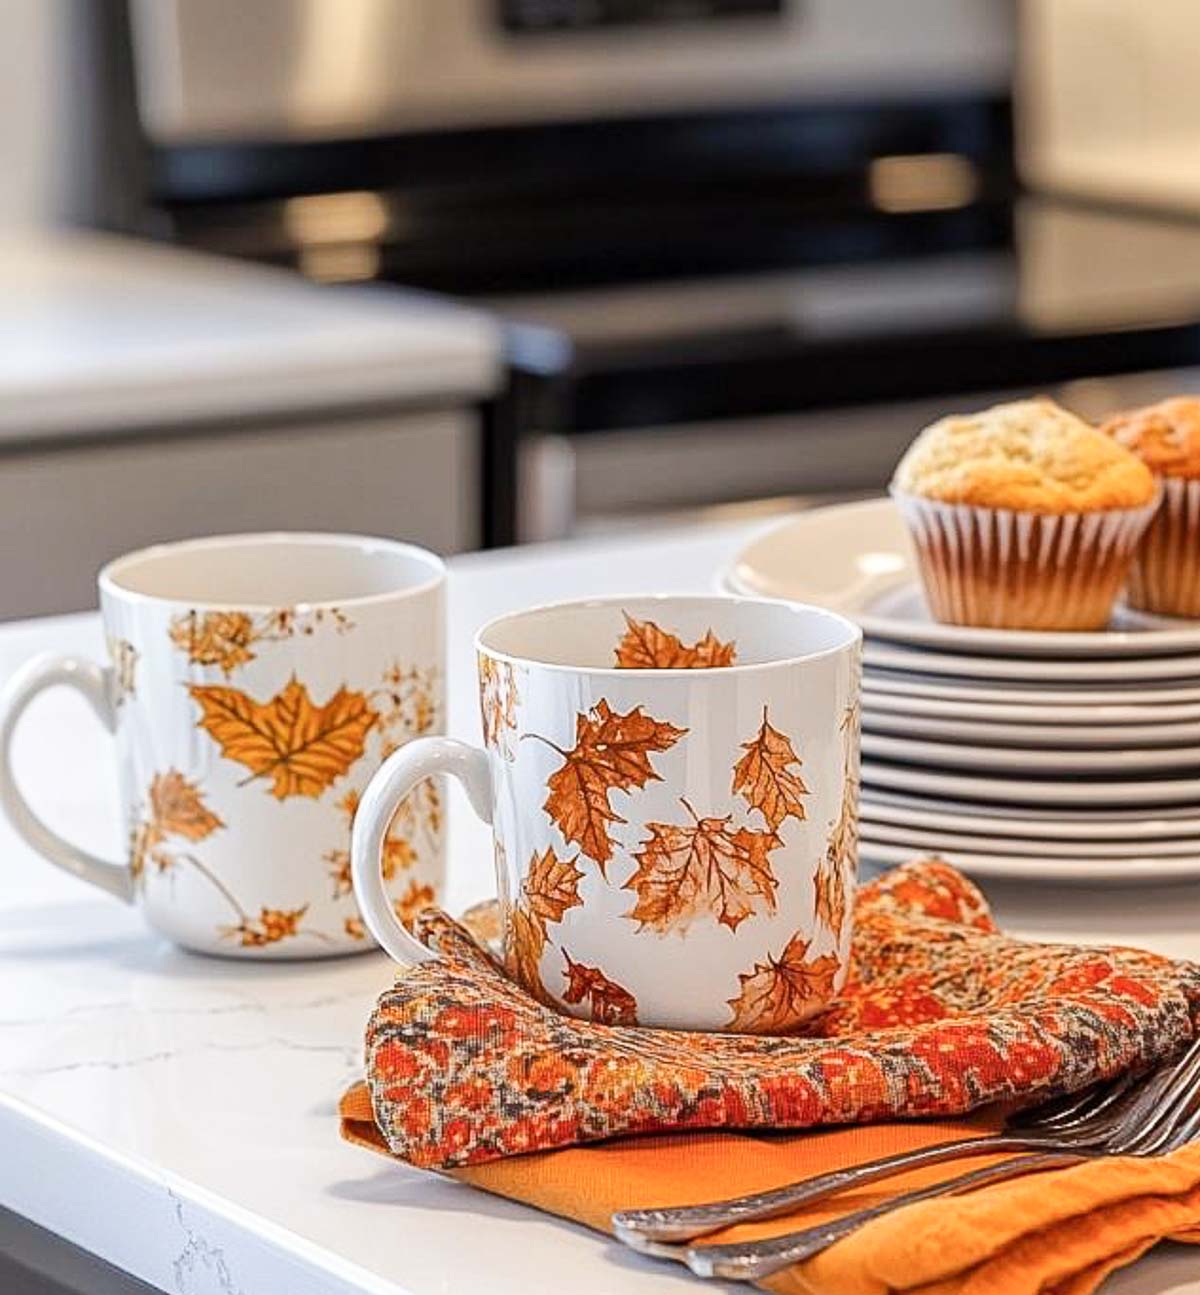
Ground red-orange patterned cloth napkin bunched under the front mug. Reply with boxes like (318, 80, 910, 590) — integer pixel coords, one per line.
(341, 861, 1200, 1170)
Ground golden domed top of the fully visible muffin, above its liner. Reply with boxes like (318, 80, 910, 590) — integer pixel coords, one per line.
(892, 396, 1156, 513)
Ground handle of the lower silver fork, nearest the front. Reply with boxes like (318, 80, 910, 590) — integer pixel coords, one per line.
(686, 1150, 1100, 1282)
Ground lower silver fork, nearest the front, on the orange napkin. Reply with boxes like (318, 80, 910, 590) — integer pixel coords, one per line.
(673, 1045, 1200, 1281)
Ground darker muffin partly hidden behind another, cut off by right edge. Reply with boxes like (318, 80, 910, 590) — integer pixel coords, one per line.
(1102, 396, 1200, 616)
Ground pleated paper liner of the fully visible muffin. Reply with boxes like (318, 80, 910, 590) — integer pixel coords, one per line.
(892, 491, 1159, 629)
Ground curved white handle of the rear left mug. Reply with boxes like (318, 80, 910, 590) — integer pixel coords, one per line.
(0, 657, 133, 904)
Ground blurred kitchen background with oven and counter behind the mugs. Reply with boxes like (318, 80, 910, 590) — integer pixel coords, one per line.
(7, 0, 1200, 618)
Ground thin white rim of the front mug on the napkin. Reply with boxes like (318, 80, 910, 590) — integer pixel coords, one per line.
(474, 593, 862, 679)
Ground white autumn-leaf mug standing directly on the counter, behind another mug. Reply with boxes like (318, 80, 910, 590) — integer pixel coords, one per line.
(0, 534, 445, 958)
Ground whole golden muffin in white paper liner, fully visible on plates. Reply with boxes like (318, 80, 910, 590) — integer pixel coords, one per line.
(892, 399, 1157, 629)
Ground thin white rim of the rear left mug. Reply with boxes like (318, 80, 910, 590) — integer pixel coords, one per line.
(96, 531, 447, 613)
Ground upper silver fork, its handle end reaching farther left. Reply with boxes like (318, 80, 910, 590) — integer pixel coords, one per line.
(612, 1039, 1200, 1252)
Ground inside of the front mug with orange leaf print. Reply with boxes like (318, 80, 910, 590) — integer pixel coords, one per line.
(478, 594, 861, 671)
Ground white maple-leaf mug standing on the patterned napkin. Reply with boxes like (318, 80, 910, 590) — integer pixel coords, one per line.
(351, 596, 861, 1033)
